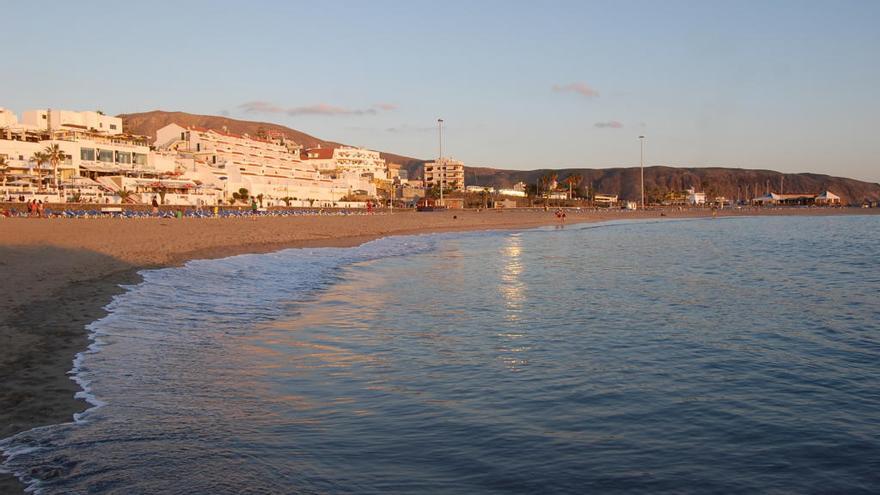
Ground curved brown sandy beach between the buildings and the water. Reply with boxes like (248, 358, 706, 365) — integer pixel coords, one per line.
(0, 209, 880, 493)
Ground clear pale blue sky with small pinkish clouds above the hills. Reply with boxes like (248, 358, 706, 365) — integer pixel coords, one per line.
(0, 0, 880, 182)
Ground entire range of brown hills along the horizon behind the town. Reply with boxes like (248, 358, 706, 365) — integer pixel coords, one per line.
(119, 110, 880, 203)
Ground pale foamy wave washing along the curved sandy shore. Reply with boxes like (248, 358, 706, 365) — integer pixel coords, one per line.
(0, 231, 497, 494)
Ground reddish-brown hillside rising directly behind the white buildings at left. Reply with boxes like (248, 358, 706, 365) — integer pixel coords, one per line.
(118, 110, 422, 166)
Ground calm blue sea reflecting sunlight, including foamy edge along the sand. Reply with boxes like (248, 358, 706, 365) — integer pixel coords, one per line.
(0, 216, 880, 494)
